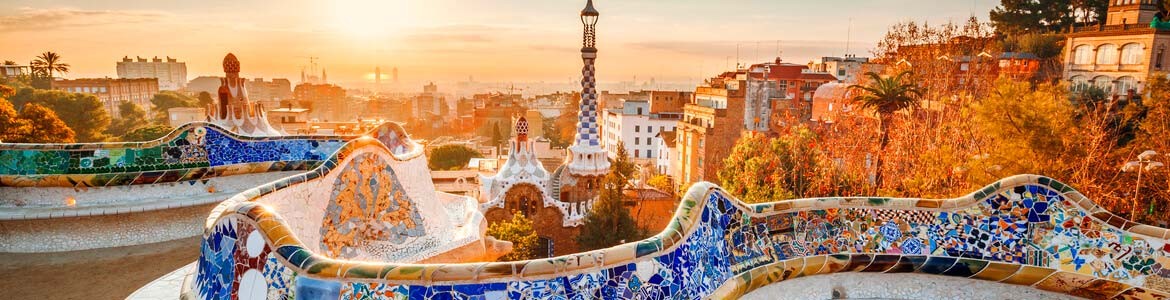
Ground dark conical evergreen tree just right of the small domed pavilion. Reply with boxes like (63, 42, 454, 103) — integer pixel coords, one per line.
(577, 142, 646, 251)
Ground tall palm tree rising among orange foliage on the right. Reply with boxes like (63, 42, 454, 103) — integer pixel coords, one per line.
(849, 70, 922, 189)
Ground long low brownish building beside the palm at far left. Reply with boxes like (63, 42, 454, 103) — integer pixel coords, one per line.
(53, 79, 158, 117)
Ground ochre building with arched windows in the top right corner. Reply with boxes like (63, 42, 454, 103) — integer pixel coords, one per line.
(1064, 0, 1170, 98)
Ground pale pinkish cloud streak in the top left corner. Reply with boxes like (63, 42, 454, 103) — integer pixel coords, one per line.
(0, 7, 168, 32)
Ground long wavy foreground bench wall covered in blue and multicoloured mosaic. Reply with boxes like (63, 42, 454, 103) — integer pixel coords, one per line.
(184, 176, 1170, 299)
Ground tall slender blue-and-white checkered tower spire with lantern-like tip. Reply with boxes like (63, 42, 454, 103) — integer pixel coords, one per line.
(569, 0, 610, 176)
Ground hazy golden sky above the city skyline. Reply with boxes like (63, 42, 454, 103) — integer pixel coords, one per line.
(0, 0, 998, 87)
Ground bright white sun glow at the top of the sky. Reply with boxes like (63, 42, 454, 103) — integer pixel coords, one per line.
(330, 0, 412, 38)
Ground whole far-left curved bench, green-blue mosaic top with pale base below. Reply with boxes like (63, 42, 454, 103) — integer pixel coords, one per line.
(0, 122, 405, 252)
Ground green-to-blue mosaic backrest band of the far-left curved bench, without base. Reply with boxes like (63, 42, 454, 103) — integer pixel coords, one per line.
(0, 122, 356, 188)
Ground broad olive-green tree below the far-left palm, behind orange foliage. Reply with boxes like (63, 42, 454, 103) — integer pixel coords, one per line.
(9, 88, 110, 143)
